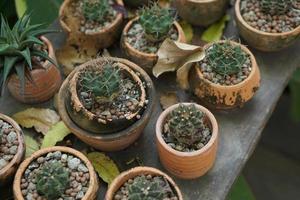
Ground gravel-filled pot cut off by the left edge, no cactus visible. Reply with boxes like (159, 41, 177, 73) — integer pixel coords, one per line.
(0, 113, 25, 186)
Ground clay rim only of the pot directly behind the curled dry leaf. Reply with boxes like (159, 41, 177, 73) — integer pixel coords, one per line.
(122, 16, 185, 59)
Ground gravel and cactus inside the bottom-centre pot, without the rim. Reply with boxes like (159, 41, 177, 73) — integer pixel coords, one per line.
(113, 174, 179, 200)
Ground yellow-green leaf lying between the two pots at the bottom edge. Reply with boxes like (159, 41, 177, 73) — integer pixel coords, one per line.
(87, 152, 120, 184)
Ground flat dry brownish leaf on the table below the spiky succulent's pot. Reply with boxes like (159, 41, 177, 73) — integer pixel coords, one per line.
(12, 108, 60, 135)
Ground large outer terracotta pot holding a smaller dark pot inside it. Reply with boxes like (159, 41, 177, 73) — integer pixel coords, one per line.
(58, 58, 155, 151)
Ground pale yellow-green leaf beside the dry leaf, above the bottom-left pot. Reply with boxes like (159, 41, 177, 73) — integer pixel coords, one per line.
(41, 121, 71, 148)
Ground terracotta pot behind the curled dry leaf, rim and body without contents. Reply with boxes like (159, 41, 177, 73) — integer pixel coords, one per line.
(121, 17, 186, 74)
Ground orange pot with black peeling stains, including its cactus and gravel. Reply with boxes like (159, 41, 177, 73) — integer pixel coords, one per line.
(189, 40, 260, 109)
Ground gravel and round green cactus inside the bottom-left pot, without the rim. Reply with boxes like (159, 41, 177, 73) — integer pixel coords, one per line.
(20, 151, 90, 200)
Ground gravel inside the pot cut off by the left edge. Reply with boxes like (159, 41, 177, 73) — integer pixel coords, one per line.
(0, 119, 20, 170)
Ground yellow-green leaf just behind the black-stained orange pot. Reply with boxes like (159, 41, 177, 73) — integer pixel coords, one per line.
(201, 15, 230, 42)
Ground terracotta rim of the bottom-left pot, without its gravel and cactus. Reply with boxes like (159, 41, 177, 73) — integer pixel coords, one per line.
(13, 146, 99, 200)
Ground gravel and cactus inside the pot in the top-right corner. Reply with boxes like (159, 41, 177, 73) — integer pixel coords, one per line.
(240, 0, 300, 33)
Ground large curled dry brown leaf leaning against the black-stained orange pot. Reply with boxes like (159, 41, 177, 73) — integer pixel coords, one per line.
(152, 39, 205, 89)
